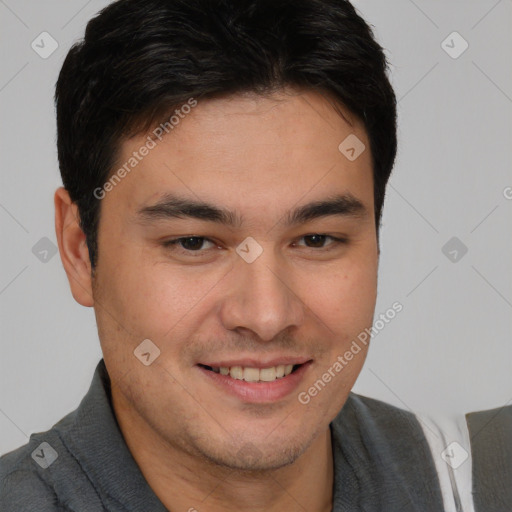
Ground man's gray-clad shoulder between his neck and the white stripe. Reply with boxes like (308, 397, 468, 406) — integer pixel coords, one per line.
(331, 393, 443, 512)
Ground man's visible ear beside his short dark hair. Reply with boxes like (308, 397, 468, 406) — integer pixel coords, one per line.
(54, 187, 94, 307)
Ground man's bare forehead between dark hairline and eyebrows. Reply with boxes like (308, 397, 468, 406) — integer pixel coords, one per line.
(105, 90, 373, 222)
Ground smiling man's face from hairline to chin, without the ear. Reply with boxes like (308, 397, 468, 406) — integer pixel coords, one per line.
(93, 90, 378, 469)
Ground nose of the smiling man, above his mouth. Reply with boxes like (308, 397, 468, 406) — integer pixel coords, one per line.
(220, 250, 306, 341)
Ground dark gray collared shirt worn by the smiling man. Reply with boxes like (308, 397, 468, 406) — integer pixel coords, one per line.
(0, 360, 512, 512)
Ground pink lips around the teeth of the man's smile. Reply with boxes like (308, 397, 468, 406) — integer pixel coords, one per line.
(195, 359, 313, 404)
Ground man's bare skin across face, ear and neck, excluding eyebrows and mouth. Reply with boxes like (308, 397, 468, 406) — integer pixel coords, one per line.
(55, 89, 378, 512)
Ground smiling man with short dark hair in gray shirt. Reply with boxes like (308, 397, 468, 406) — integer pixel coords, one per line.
(0, 0, 511, 512)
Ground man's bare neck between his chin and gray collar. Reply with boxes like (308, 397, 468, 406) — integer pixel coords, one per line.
(113, 388, 333, 512)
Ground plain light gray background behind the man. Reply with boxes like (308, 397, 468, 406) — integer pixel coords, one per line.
(0, 0, 512, 453)
